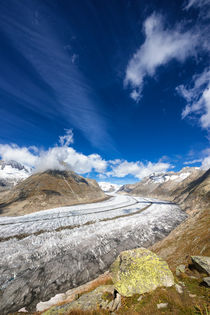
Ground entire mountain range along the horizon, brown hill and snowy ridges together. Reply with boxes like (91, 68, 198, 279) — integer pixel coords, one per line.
(0, 160, 210, 214)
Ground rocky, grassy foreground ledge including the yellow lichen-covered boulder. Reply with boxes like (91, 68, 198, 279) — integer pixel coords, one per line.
(35, 248, 210, 315)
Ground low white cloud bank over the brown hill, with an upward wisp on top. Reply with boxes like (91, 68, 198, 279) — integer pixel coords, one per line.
(0, 130, 107, 174)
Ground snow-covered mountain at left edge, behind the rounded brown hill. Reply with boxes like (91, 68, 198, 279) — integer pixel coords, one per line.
(0, 160, 31, 191)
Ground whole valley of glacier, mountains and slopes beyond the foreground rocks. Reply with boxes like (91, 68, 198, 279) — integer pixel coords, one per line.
(0, 161, 209, 314)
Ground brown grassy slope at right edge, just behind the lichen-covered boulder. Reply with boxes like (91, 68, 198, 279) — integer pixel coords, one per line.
(150, 206, 210, 268)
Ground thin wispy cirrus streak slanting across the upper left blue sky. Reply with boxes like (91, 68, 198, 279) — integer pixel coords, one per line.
(0, 0, 112, 147)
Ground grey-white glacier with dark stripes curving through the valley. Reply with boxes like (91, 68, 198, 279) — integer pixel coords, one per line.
(0, 196, 186, 314)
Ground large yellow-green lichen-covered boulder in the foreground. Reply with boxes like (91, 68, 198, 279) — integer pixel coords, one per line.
(111, 248, 174, 296)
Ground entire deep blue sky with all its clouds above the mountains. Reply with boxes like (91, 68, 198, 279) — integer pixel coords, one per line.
(0, 0, 210, 183)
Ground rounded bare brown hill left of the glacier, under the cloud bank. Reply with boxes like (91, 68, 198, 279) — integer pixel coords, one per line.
(0, 170, 107, 215)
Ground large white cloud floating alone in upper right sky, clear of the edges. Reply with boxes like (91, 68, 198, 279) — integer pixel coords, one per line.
(124, 14, 197, 102)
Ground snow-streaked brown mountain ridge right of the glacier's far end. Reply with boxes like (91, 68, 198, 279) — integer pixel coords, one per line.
(119, 167, 210, 210)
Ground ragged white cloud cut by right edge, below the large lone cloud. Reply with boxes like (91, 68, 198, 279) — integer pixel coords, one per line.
(177, 68, 210, 129)
